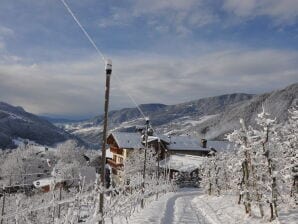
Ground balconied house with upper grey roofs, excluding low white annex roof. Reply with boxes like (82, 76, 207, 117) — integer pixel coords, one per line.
(107, 132, 217, 175)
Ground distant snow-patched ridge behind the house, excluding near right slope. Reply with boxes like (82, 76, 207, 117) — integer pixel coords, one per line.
(61, 93, 253, 144)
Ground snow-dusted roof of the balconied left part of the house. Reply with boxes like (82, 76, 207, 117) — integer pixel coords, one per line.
(111, 132, 144, 149)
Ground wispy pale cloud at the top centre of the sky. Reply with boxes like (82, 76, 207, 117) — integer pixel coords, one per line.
(99, 0, 217, 35)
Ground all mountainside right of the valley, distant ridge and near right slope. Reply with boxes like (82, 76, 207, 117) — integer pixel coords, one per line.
(64, 83, 298, 143)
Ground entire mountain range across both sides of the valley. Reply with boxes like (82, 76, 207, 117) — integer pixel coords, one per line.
(0, 83, 298, 148)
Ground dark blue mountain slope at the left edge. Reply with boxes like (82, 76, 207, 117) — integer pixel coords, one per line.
(0, 102, 70, 148)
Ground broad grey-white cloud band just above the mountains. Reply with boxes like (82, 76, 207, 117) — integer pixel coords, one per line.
(0, 49, 298, 115)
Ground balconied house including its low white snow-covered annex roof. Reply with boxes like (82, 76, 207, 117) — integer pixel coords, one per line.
(107, 132, 231, 186)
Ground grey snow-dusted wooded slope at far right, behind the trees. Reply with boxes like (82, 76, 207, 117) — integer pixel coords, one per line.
(193, 83, 298, 139)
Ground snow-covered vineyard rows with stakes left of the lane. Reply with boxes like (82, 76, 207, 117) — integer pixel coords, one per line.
(0, 172, 175, 224)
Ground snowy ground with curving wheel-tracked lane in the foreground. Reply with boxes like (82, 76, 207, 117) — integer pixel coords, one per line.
(106, 188, 298, 224)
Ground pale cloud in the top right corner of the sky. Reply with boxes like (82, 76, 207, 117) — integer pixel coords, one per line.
(223, 0, 298, 24)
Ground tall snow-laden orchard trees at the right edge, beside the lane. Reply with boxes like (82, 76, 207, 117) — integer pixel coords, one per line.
(228, 108, 297, 220)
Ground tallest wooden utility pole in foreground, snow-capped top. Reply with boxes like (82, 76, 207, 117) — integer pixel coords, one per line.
(99, 59, 112, 224)
